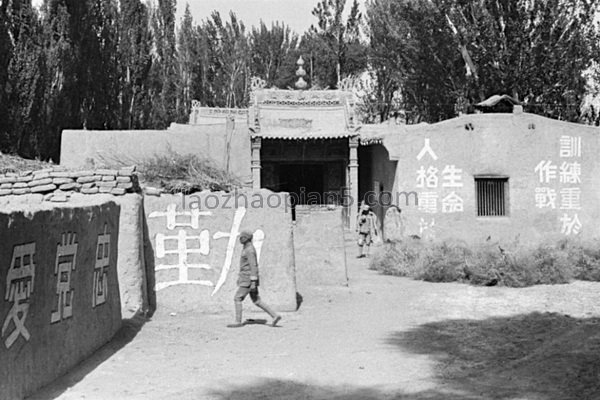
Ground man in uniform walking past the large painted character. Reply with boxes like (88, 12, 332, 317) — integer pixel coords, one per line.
(227, 231, 281, 328)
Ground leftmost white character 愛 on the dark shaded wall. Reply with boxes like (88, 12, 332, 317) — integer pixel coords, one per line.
(2, 242, 35, 349)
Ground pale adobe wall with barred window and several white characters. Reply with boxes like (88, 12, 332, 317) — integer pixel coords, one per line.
(384, 114, 600, 244)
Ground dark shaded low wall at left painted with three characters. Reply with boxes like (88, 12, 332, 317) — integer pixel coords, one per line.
(0, 195, 121, 399)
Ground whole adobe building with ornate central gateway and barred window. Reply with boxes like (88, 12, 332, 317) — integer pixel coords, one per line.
(61, 70, 600, 241)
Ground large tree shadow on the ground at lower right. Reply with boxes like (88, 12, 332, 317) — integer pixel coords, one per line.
(205, 313, 600, 400)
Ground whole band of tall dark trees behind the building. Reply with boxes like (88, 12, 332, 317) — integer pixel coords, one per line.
(0, 0, 600, 161)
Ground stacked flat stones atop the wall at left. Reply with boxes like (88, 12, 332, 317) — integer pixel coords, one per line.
(0, 166, 140, 202)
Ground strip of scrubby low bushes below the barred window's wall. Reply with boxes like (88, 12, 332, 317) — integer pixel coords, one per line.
(370, 239, 600, 287)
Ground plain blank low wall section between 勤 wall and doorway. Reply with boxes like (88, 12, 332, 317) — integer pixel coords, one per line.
(294, 206, 348, 293)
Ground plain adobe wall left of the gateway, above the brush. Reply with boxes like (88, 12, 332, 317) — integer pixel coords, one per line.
(60, 121, 252, 183)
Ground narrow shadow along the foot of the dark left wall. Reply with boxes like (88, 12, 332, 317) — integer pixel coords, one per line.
(27, 315, 148, 400)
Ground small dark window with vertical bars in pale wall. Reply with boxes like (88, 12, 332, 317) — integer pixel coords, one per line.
(475, 177, 508, 217)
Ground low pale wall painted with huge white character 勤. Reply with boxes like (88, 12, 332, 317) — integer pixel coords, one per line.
(144, 190, 296, 312)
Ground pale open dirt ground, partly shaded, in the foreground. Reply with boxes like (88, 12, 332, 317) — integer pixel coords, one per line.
(29, 238, 600, 400)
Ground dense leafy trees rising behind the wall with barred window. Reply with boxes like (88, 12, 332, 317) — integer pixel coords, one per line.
(368, 0, 599, 122)
